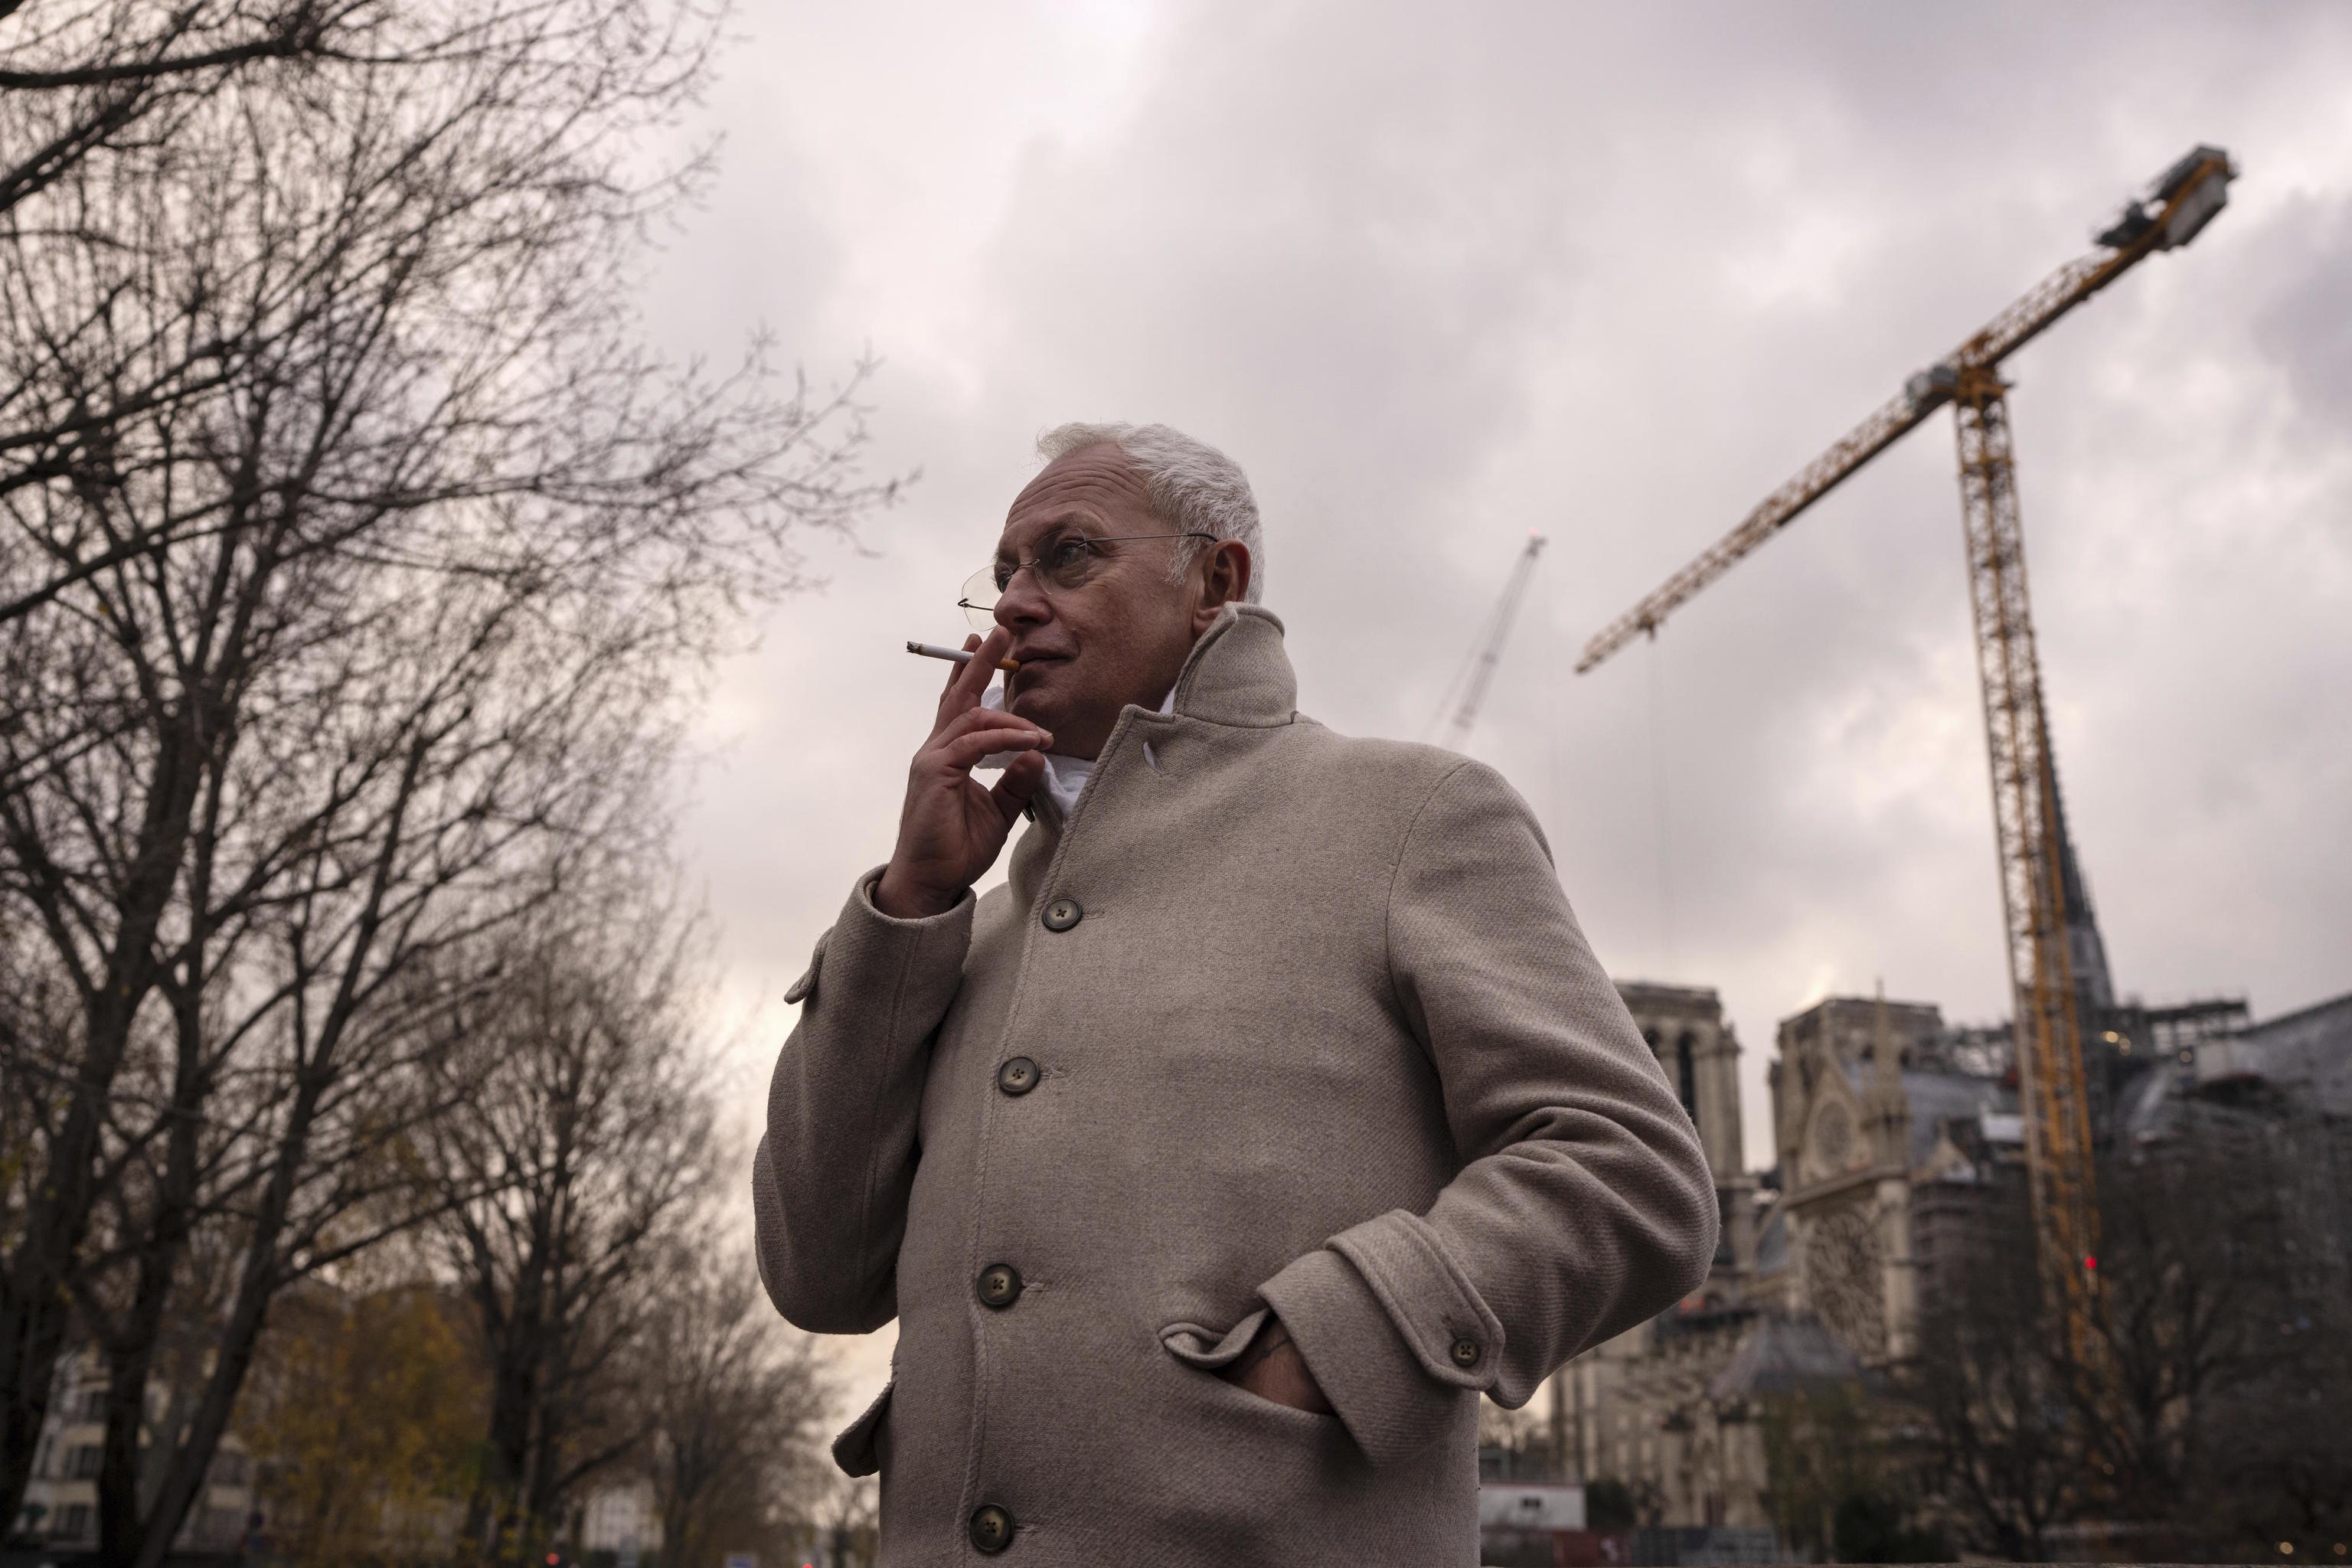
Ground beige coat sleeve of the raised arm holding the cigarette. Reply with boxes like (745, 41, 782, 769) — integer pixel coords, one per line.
(750, 870, 974, 1333)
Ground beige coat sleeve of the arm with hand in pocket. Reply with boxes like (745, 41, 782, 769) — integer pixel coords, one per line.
(1261, 762, 1720, 1462)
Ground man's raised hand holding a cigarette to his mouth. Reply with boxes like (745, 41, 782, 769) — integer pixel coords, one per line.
(875, 626, 1054, 920)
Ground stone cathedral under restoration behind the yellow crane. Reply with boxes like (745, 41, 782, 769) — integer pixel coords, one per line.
(1540, 964, 2305, 1528)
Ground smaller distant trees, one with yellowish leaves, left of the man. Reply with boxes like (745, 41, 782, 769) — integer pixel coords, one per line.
(235, 922, 830, 1563)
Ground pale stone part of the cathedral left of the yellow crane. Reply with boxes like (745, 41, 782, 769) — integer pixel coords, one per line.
(1545, 982, 2023, 1528)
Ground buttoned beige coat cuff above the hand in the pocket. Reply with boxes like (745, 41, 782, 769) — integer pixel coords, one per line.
(1259, 1248, 1463, 1467)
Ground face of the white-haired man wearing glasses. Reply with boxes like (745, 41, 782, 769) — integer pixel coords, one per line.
(995, 446, 1200, 757)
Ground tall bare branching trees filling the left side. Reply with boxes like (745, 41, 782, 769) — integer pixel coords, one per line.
(0, 0, 889, 1568)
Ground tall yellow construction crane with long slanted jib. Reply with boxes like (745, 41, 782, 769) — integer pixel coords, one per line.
(1576, 145, 2236, 1357)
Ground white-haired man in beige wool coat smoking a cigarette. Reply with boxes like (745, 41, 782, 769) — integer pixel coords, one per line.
(753, 426, 1717, 1568)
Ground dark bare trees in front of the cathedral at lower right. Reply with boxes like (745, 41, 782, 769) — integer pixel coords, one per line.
(1759, 1129, 2352, 1561)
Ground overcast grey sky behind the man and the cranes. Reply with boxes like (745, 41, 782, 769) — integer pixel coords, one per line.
(647, 0, 2352, 1419)
